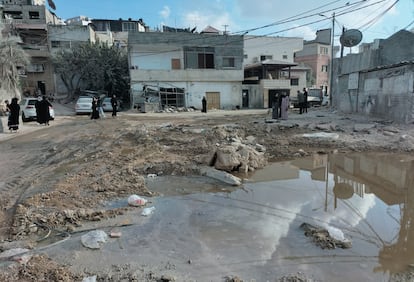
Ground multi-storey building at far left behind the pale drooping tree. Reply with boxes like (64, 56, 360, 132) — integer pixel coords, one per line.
(2, 0, 60, 95)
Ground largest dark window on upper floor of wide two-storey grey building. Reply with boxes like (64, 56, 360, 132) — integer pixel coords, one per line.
(184, 47, 214, 69)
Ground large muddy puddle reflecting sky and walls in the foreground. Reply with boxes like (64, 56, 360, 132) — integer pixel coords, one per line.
(43, 154, 414, 281)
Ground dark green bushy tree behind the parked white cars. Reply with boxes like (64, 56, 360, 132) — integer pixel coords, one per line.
(53, 43, 129, 102)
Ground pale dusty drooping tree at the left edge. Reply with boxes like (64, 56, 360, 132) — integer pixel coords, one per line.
(0, 22, 29, 102)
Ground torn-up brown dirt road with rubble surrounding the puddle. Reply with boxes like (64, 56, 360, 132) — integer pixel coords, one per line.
(0, 108, 414, 281)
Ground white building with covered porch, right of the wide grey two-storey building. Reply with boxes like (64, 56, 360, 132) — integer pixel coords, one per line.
(242, 36, 309, 108)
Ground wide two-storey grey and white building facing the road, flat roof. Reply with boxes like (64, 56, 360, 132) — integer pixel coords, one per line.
(128, 29, 243, 109)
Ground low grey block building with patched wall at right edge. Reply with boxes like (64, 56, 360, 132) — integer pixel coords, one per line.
(332, 30, 414, 123)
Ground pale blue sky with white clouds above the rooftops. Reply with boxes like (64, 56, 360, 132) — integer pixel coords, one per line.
(50, 0, 414, 42)
